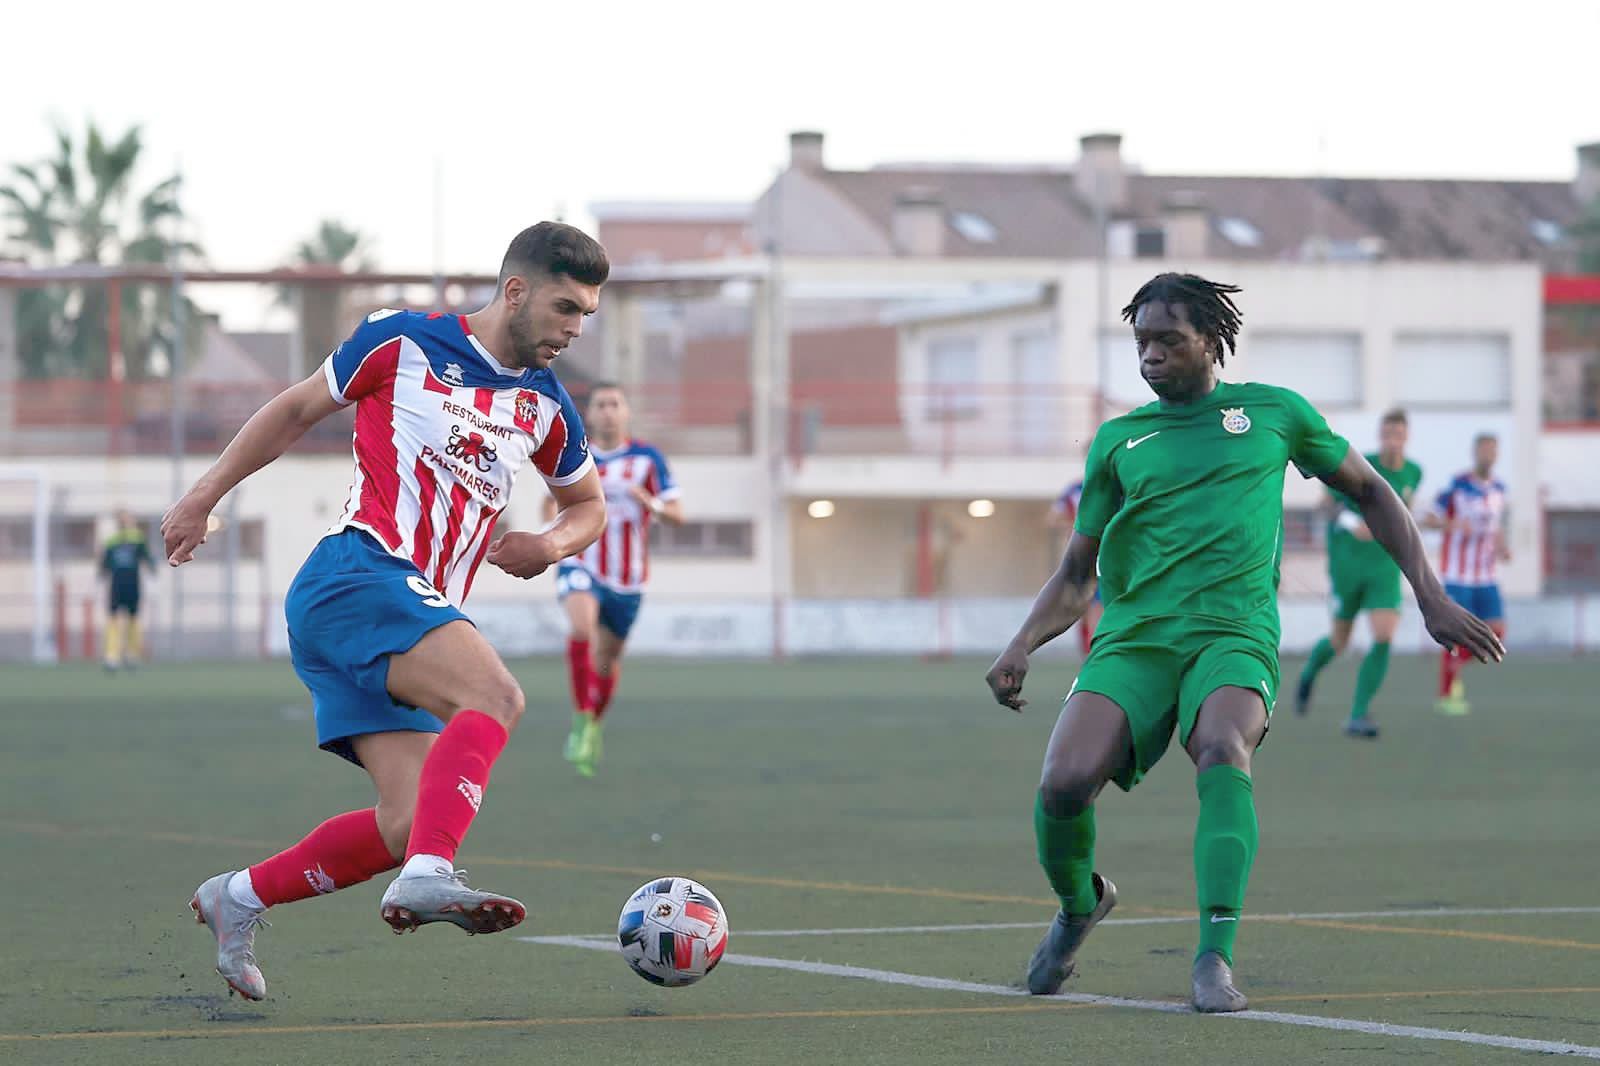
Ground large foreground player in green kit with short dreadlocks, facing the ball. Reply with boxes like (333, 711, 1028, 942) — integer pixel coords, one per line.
(987, 274, 1504, 1012)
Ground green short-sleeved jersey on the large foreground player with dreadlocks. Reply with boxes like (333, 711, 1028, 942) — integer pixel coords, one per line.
(1075, 383, 1350, 648)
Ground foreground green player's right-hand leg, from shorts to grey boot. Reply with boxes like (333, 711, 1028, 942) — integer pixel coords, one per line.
(1179, 640, 1278, 1012)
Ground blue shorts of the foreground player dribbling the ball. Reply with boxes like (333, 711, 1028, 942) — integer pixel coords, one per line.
(283, 530, 466, 765)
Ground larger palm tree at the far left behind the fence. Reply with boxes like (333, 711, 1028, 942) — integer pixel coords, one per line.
(0, 122, 200, 378)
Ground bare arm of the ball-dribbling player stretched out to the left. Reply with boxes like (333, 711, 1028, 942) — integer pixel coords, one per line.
(162, 368, 339, 567)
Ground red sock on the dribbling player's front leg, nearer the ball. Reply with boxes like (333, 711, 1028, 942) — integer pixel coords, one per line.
(405, 711, 507, 861)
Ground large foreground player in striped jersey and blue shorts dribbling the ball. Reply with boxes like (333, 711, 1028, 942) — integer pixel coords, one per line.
(162, 222, 610, 999)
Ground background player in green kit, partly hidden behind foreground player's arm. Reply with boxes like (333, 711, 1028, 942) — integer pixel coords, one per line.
(1294, 410, 1422, 739)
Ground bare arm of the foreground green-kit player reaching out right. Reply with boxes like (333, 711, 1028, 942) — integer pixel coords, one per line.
(1322, 448, 1506, 663)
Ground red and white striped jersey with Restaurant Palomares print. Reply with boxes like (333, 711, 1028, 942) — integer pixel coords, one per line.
(322, 311, 594, 607)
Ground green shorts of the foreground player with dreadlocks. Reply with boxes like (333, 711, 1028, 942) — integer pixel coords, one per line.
(1067, 626, 1278, 792)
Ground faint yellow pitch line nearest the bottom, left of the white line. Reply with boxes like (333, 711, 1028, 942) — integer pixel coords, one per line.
(0, 1002, 1099, 1044)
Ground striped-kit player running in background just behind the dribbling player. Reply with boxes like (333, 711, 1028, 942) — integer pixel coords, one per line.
(555, 381, 683, 778)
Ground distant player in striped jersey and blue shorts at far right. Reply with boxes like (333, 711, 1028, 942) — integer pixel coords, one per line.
(1422, 434, 1510, 714)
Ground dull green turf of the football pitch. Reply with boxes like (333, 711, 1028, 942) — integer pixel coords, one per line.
(0, 646, 1600, 1066)
